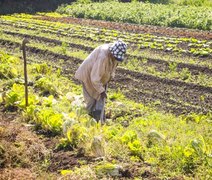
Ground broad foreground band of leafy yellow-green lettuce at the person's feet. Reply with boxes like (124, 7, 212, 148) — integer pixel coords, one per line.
(0, 52, 212, 178)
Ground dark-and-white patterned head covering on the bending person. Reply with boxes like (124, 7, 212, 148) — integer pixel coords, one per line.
(109, 40, 127, 61)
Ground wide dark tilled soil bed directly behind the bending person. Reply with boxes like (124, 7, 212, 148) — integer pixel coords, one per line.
(0, 38, 212, 115)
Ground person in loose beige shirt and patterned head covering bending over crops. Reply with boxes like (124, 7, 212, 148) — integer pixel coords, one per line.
(75, 40, 127, 121)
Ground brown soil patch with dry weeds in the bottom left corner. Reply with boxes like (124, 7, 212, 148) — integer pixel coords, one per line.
(0, 106, 79, 180)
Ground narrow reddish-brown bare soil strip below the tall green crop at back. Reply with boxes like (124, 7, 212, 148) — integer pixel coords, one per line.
(35, 16, 212, 40)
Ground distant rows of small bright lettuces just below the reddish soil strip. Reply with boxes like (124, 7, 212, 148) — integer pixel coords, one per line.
(1, 13, 212, 57)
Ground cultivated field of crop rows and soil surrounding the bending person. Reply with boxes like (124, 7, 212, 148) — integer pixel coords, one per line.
(0, 1, 212, 179)
